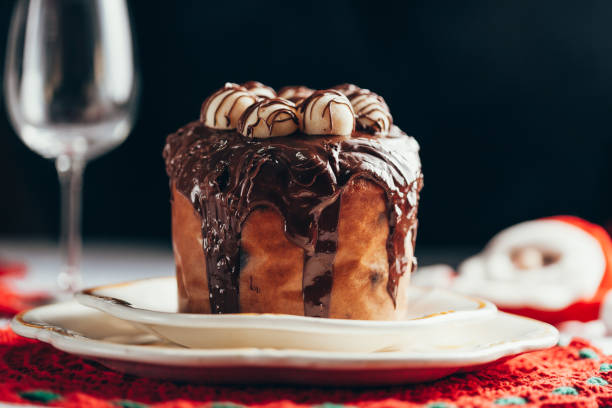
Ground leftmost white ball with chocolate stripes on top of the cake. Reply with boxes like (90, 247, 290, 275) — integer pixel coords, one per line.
(200, 82, 257, 129)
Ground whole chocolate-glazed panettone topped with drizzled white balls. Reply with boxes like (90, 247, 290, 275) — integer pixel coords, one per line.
(164, 82, 422, 320)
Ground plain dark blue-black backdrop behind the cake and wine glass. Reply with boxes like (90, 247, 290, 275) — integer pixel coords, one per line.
(0, 0, 612, 246)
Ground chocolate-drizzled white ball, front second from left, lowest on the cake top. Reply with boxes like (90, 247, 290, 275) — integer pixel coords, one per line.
(238, 98, 299, 139)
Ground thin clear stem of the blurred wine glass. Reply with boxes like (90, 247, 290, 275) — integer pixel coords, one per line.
(55, 155, 85, 295)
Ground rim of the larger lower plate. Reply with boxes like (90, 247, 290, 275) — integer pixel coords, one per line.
(10, 300, 559, 370)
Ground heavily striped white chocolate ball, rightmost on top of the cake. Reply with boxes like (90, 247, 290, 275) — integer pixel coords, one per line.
(348, 89, 393, 133)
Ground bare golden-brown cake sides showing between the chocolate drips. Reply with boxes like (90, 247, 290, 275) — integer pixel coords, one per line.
(172, 179, 412, 320)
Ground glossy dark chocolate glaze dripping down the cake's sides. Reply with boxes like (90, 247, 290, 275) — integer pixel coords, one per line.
(164, 122, 422, 317)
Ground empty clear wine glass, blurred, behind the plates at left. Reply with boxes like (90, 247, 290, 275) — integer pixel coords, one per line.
(4, 0, 139, 293)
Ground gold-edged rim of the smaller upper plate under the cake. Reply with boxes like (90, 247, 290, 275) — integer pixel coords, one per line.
(75, 276, 498, 332)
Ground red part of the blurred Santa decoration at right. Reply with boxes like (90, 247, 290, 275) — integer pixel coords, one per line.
(500, 215, 612, 324)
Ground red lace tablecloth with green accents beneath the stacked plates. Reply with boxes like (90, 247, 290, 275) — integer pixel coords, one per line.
(0, 264, 612, 408)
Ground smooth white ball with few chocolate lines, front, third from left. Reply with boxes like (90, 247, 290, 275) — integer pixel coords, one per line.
(299, 89, 355, 136)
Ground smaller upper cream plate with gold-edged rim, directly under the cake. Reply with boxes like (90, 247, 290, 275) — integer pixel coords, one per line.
(76, 277, 497, 352)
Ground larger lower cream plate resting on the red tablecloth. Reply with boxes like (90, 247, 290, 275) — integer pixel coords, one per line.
(11, 301, 558, 386)
